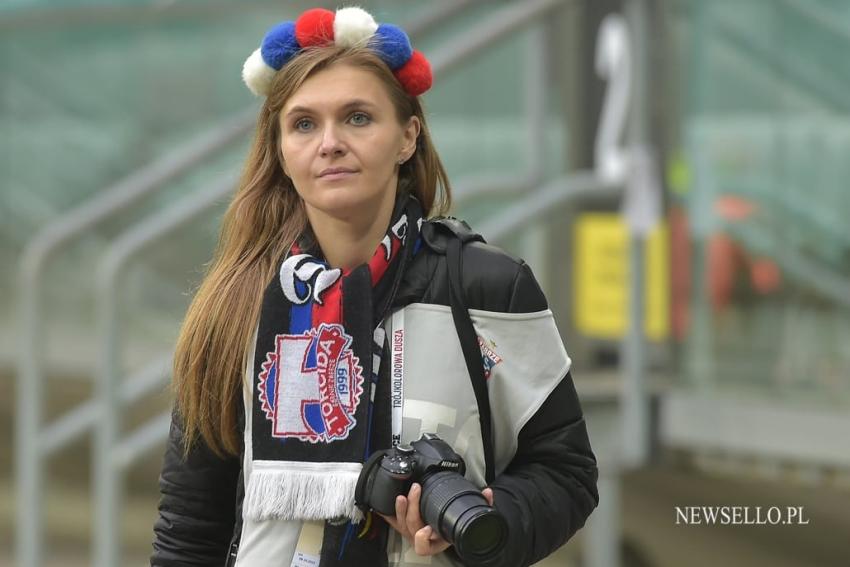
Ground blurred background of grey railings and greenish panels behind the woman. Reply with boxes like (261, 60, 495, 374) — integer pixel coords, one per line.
(0, 0, 850, 567)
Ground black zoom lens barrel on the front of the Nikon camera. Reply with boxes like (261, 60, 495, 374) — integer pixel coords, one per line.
(420, 471, 508, 565)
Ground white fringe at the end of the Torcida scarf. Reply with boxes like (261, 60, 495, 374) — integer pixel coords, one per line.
(244, 461, 363, 522)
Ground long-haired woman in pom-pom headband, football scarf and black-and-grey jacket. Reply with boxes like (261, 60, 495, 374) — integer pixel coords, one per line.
(151, 8, 598, 567)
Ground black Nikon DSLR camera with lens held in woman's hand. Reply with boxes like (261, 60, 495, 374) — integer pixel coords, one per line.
(355, 433, 508, 565)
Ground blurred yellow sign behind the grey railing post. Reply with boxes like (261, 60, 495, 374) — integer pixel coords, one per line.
(573, 213, 670, 340)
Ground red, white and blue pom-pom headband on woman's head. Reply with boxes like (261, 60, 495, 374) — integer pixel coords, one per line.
(242, 7, 432, 96)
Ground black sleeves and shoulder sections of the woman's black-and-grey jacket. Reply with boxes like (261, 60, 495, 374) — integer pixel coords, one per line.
(151, 221, 599, 567)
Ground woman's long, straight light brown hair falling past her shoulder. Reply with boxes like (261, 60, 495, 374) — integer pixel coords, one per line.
(174, 46, 451, 456)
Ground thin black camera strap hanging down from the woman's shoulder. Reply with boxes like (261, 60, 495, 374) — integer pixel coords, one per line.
(446, 237, 496, 484)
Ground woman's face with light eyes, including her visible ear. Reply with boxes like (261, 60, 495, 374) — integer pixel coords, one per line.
(278, 64, 419, 225)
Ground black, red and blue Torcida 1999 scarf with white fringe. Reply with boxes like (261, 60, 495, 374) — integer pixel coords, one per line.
(244, 195, 422, 567)
